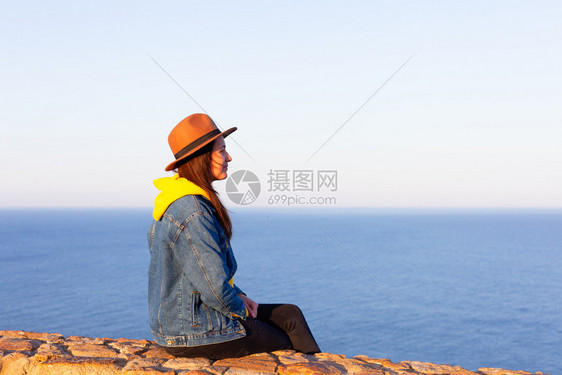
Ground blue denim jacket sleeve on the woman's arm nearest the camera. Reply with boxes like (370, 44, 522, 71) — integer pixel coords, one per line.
(173, 212, 246, 319)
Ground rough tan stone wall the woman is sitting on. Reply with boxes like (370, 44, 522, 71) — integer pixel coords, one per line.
(0, 331, 542, 375)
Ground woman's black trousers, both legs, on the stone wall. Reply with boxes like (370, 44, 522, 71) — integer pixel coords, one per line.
(164, 304, 320, 359)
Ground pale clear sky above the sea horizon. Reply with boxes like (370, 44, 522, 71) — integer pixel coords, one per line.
(0, 0, 562, 207)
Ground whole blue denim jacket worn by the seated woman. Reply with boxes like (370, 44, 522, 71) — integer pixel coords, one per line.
(148, 195, 246, 346)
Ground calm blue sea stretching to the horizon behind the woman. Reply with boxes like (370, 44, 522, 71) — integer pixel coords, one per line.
(0, 209, 562, 374)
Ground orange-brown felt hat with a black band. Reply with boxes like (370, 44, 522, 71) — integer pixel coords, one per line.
(166, 113, 238, 171)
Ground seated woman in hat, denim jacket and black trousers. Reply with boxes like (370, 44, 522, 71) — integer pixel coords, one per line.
(148, 114, 320, 359)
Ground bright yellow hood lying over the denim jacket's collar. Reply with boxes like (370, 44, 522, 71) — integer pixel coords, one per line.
(152, 174, 211, 220)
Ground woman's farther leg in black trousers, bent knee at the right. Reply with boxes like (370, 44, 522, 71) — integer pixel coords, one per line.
(257, 304, 320, 354)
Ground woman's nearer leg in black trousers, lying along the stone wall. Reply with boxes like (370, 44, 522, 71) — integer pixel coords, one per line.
(164, 318, 293, 359)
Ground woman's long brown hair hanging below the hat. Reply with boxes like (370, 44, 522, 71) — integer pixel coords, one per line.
(173, 142, 232, 239)
